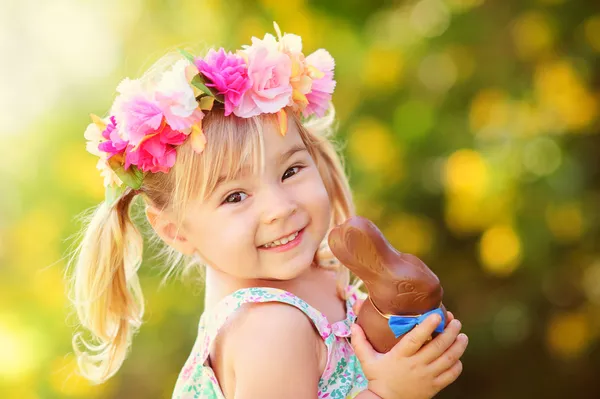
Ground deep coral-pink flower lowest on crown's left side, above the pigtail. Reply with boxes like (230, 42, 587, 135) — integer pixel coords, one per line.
(124, 120, 188, 173)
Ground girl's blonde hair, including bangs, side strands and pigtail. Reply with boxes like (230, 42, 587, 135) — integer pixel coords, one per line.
(69, 50, 354, 383)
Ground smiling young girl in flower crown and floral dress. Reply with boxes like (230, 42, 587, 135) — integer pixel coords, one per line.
(73, 22, 467, 399)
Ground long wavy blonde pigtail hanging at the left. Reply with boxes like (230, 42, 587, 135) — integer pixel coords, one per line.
(71, 190, 144, 383)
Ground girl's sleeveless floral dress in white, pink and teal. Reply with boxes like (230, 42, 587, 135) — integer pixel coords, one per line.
(172, 286, 367, 399)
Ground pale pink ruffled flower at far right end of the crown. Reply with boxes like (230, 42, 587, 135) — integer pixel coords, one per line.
(302, 49, 336, 117)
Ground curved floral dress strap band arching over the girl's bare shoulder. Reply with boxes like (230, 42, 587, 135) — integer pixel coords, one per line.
(199, 287, 332, 363)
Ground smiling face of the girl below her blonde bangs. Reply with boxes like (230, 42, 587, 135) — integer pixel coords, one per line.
(178, 123, 331, 280)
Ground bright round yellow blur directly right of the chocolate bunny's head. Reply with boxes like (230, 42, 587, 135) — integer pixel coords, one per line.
(479, 225, 521, 276)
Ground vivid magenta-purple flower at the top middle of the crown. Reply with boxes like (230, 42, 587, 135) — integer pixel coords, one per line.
(195, 48, 252, 116)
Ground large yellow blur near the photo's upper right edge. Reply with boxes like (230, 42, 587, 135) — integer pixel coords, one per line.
(534, 61, 598, 130)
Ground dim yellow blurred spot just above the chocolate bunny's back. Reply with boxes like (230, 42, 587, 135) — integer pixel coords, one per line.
(383, 214, 434, 256)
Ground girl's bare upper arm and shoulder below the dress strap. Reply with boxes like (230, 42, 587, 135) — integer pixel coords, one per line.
(220, 303, 326, 399)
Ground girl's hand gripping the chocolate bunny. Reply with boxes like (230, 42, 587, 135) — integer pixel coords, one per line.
(352, 312, 468, 399)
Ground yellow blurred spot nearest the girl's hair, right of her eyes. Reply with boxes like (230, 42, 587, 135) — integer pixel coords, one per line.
(348, 118, 404, 182)
